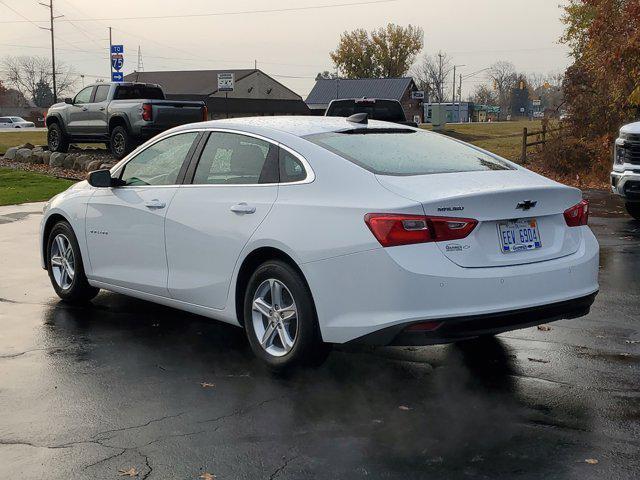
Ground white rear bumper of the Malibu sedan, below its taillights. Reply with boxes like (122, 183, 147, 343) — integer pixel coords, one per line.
(301, 227, 599, 344)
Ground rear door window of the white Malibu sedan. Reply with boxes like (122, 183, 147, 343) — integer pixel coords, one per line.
(193, 132, 278, 185)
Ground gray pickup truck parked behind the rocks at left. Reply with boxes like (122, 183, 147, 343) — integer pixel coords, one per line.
(46, 83, 208, 159)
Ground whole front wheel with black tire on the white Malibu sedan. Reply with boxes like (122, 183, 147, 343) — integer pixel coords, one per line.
(46, 221, 100, 303)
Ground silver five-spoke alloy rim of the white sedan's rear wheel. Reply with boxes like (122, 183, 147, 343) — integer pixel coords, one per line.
(252, 278, 298, 357)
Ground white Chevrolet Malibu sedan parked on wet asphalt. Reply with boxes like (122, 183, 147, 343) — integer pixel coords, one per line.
(40, 114, 598, 368)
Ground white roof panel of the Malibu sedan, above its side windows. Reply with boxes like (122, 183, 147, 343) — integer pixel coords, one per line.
(174, 115, 410, 137)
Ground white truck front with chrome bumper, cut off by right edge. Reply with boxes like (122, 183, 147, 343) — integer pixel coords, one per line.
(611, 122, 640, 220)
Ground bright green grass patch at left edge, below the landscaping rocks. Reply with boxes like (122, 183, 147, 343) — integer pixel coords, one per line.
(0, 168, 74, 205)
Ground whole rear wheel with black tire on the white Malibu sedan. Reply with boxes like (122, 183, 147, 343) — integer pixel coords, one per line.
(244, 260, 330, 372)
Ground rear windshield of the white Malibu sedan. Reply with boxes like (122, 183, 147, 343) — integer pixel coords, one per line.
(305, 128, 513, 175)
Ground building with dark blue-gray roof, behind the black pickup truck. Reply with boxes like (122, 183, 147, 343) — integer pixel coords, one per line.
(305, 77, 423, 122)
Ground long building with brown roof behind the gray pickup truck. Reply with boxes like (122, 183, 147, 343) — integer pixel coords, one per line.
(124, 69, 310, 119)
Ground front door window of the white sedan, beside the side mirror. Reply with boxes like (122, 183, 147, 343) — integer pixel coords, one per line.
(120, 132, 198, 186)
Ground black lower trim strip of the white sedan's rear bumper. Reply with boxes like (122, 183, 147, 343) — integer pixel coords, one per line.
(349, 292, 597, 346)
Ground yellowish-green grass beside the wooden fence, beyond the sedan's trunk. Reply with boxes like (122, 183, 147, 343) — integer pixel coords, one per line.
(428, 120, 542, 162)
